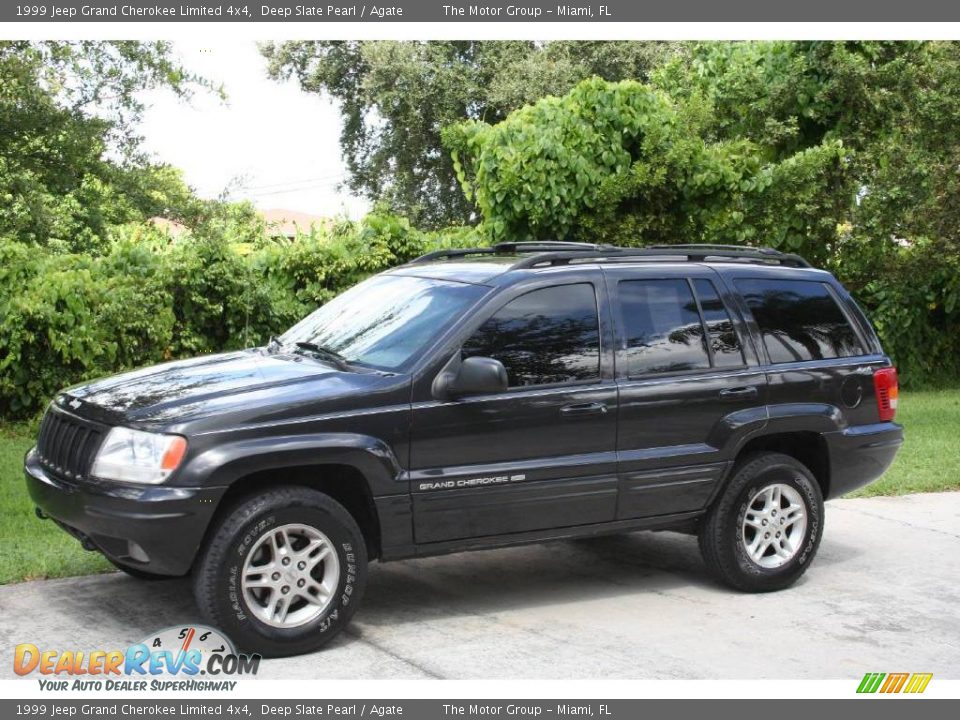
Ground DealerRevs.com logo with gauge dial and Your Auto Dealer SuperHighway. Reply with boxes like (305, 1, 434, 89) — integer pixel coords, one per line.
(13, 625, 260, 692)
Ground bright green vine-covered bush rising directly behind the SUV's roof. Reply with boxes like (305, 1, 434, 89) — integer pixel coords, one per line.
(444, 78, 849, 268)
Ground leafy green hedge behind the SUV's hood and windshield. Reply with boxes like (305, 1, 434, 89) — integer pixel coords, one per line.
(0, 214, 475, 417)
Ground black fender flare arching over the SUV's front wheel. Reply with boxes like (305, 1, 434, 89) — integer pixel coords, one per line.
(177, 433, 409, 498)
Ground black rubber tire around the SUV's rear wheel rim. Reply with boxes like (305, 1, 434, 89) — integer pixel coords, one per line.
(699, 452, 824, 592)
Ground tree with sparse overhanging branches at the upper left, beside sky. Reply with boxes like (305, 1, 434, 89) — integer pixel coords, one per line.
(0, 41, 214, 249)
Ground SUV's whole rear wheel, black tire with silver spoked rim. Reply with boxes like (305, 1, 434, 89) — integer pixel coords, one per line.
(699, 452, 823, 592)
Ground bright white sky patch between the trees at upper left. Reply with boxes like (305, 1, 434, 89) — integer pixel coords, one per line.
(140, 40, 368, 219)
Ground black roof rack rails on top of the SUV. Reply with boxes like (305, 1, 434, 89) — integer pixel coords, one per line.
(409, 241, 812, 270)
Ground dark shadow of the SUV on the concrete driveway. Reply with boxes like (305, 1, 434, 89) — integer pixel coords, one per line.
(0, 532, 859, 645)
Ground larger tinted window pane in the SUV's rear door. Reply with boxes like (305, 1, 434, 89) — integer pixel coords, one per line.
(618, 278, 710, 376)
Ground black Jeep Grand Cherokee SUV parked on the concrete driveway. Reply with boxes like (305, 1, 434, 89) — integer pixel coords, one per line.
(26, 243, 902, 655)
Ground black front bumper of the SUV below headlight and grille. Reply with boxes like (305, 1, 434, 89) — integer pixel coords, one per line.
(24, 450, 225, 575)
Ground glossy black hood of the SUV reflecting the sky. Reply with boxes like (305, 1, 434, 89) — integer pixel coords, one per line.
(57, 350, 400, 425)
